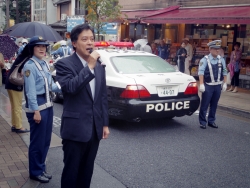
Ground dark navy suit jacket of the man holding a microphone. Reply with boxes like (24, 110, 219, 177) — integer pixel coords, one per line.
(55, 53, 109, 142)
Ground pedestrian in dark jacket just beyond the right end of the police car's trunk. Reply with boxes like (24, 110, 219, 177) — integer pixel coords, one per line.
(175, 42, 187, 73)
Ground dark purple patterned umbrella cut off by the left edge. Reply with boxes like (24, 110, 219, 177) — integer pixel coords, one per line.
(0, 35, 18, 59)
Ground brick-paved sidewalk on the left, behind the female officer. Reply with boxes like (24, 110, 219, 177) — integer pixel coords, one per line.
(0, 92, 61, 188)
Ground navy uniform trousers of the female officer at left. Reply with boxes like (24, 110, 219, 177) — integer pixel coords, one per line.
(26, 95, 53, 176)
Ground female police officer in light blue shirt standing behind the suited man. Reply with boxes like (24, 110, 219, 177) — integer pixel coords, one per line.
(23, 36, 60, 183)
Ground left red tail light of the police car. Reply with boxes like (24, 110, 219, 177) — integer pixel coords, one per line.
(120, 85, 150, 99)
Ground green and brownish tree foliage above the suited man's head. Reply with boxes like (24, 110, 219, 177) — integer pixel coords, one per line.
(81, 0, 122, 40)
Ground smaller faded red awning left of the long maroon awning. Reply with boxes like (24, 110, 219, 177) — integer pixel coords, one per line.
(122, 6, 180, 23)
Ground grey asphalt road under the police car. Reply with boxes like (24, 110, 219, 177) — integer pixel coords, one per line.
(0, 87, 250, 188)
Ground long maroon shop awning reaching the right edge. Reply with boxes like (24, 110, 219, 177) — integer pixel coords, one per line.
(141, 6, 250, 24)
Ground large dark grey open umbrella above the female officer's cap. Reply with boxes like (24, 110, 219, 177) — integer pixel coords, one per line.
(3, 22, 62, 42)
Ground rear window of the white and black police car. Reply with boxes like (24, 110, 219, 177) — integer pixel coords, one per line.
(111, 56, 176, 74)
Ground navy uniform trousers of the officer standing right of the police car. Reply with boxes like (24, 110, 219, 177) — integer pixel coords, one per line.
(199, 84, 221, 125)
